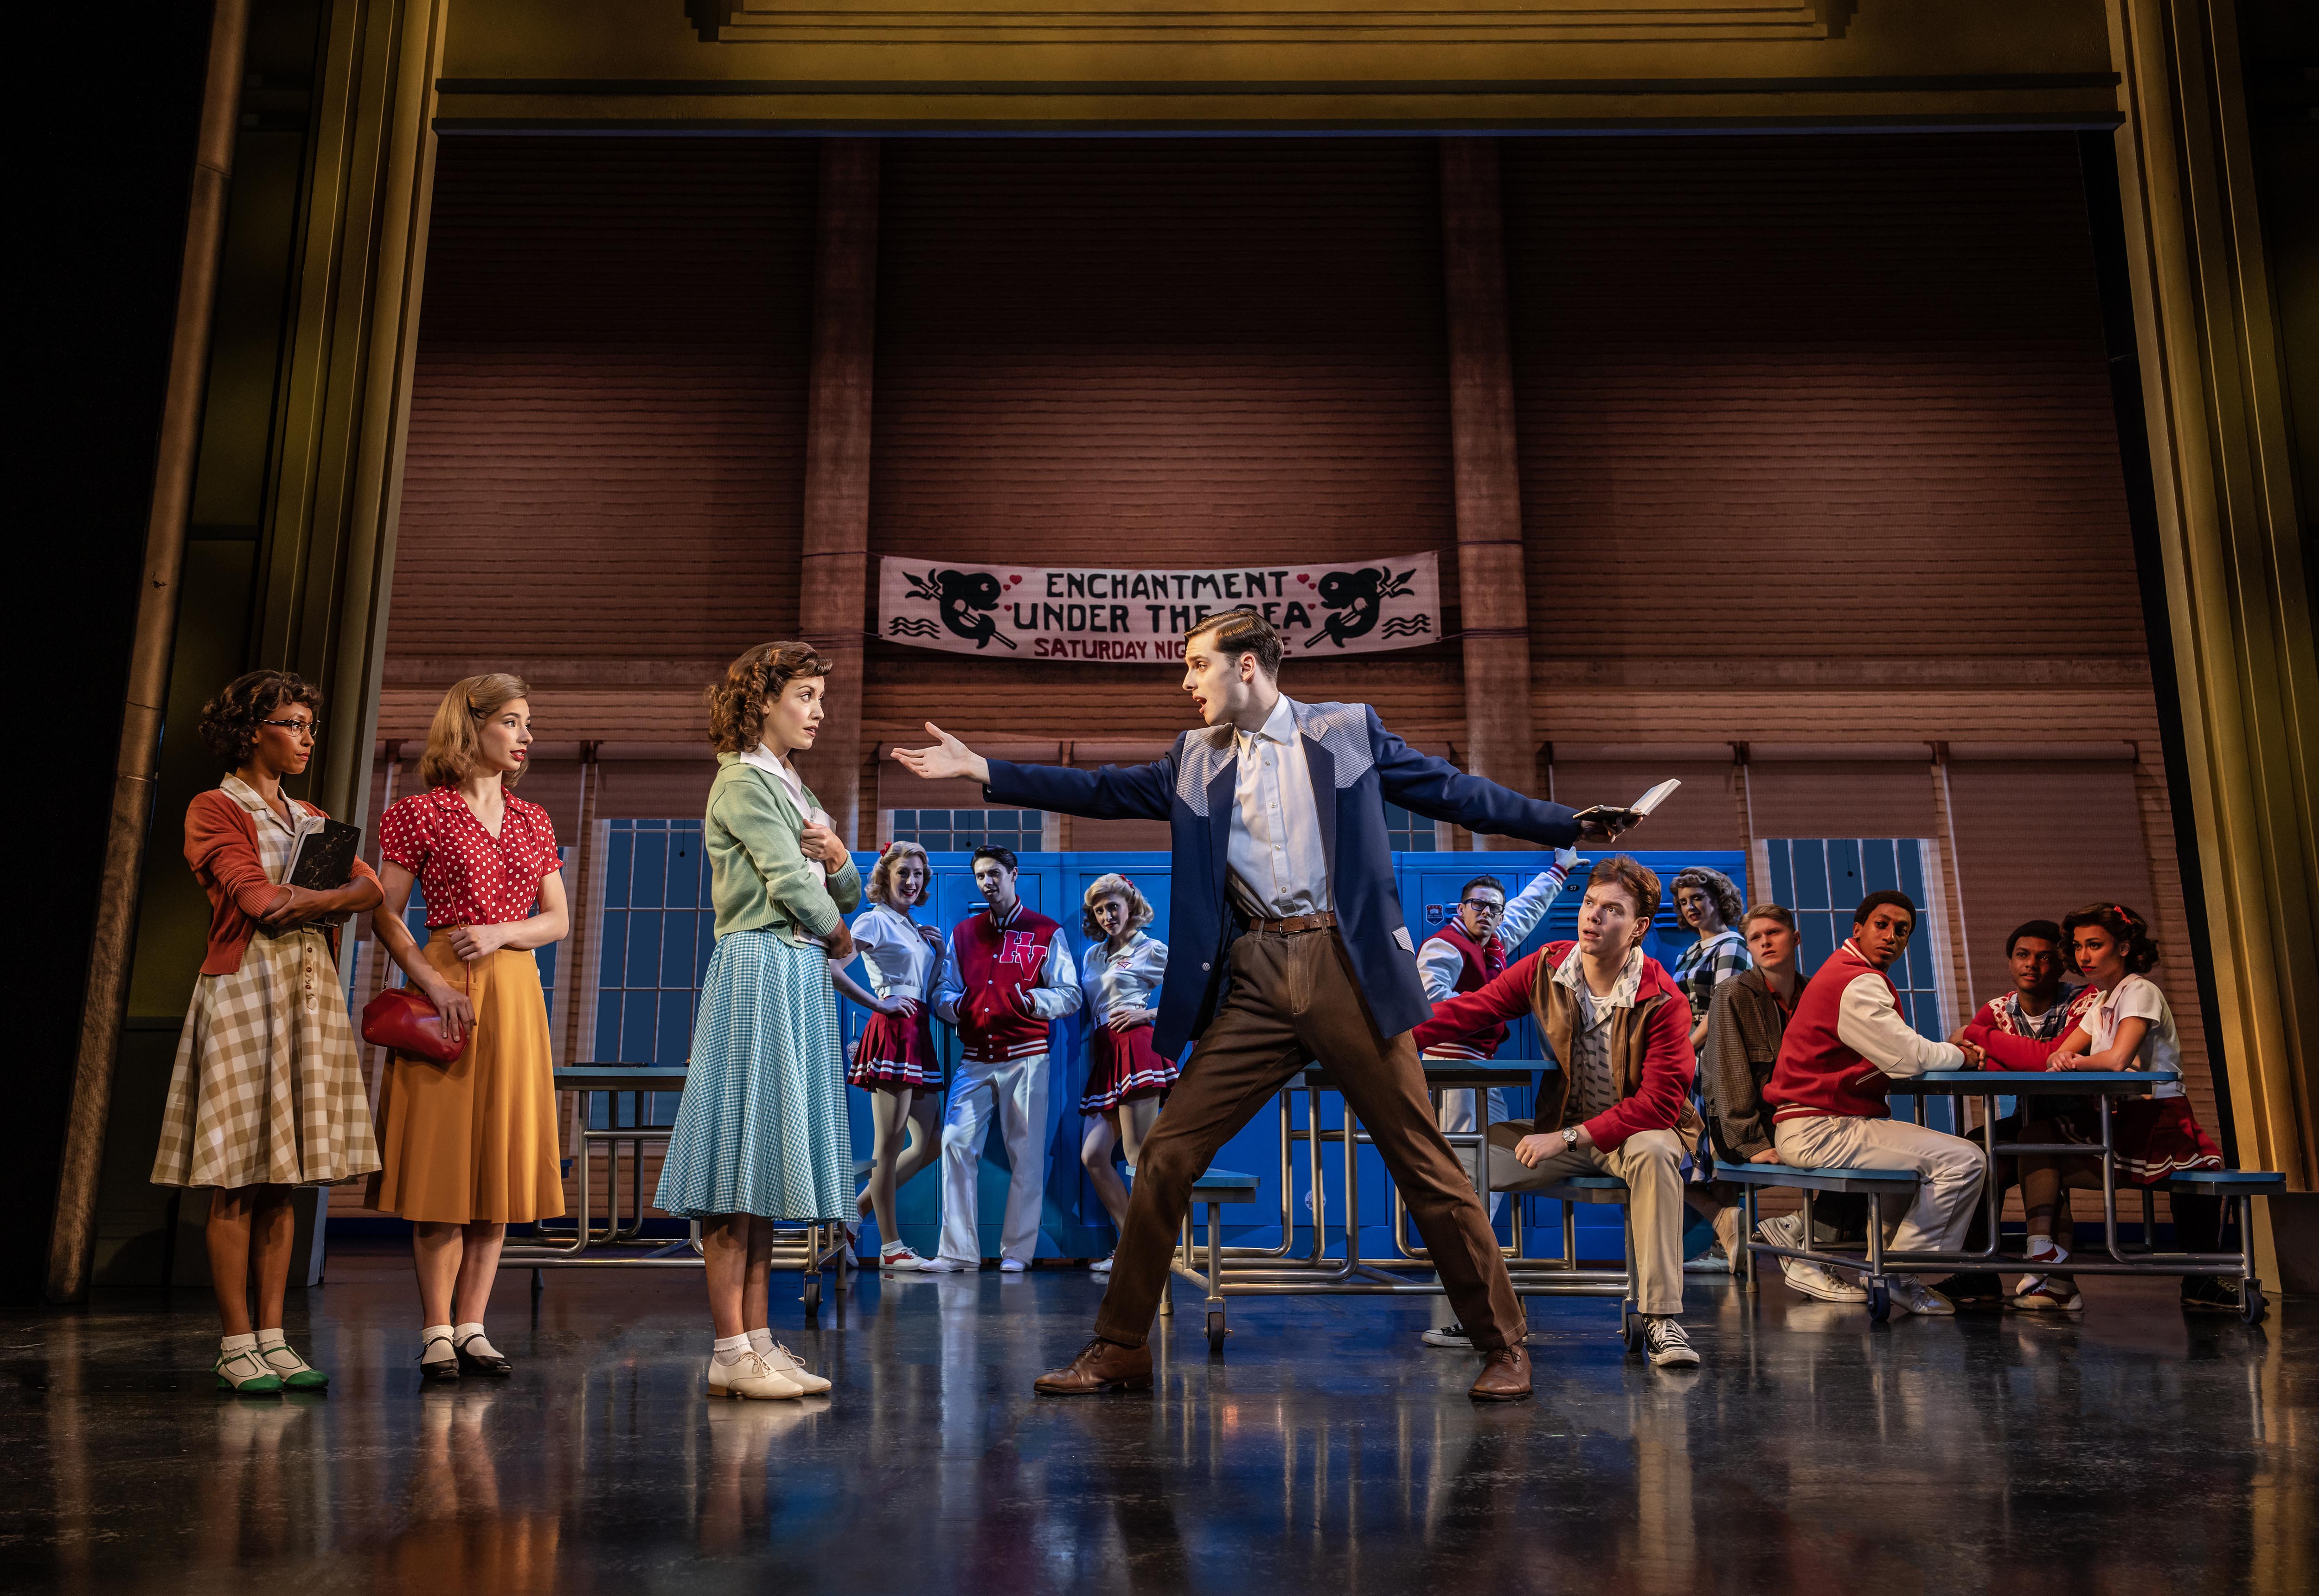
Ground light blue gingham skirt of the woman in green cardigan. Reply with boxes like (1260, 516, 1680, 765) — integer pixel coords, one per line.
(654, 930, 853, 1220)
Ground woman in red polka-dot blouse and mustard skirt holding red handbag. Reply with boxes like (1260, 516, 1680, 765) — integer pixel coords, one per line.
(371, 670, 570, 1380)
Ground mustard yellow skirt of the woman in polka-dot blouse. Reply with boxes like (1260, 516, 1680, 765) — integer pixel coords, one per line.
(369, 933, 564, 1225)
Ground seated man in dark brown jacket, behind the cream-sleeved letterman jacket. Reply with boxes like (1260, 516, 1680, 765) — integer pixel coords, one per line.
(1700, 903, 1869, 1301)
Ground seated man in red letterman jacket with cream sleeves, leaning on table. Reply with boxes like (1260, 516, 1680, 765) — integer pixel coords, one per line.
(1762, 891, 1983, 1313)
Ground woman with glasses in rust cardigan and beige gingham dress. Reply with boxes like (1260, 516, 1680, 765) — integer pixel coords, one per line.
(153, 670, 378, 1397)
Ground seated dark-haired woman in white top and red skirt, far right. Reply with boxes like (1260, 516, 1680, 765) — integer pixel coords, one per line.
(1967, 903, 2222, 1313)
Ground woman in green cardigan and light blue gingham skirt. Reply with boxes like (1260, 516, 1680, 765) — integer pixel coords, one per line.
(656, 642, 863, 1397)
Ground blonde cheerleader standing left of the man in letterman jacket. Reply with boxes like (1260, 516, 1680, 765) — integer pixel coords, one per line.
(830, 842, 948, 1271)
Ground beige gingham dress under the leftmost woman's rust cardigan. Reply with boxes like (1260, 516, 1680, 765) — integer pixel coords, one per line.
(153, 777, 378, 1186)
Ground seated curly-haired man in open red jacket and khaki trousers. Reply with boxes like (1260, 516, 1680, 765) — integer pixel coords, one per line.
(1415, 854, 1700, 1369)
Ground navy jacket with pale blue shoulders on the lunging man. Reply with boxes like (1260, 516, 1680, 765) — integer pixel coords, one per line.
(983, 700, 1579, 1058)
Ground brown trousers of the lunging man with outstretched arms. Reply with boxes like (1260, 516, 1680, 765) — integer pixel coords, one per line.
(1095, 930, 1526, 1348)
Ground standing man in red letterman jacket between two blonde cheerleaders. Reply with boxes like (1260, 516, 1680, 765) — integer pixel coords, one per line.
(925, 847, 1078, 1274)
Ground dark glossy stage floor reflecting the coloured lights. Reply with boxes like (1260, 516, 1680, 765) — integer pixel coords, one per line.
(0, 1246, 2319, 1596)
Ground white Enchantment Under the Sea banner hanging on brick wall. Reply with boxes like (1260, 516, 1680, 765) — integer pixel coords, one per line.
(877, 552, 1442, 666)
